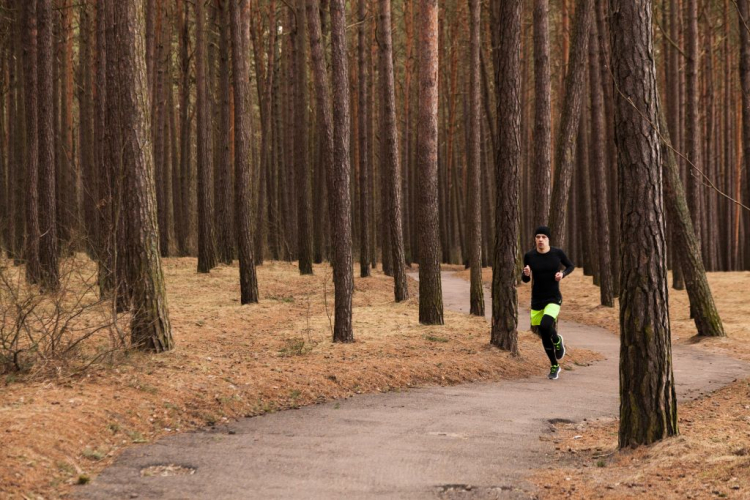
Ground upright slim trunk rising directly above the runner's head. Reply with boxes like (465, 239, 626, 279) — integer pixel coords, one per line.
(532, 0, 552, 227)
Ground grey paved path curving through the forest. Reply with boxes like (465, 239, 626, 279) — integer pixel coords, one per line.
(78, 273, 750, 500)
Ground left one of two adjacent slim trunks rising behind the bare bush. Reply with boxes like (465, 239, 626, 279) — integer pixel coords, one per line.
(23, 0, 42, 283)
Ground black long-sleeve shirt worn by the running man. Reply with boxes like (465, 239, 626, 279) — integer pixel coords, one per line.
(521, 247, 575, 311)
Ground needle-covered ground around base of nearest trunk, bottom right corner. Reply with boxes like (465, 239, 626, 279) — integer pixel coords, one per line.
(532, 381, 750, 499)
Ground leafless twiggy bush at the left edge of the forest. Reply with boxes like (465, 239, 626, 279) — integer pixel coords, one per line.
(0, 254, 127, 378)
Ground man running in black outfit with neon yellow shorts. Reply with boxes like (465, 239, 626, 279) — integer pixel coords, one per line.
(521, 226, 575, 380)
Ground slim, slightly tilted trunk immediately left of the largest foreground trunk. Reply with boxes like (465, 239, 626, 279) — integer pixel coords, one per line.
(589, 17, 614, 307)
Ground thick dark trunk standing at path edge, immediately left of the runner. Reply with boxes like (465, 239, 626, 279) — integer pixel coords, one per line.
(490, 0, 523, 355)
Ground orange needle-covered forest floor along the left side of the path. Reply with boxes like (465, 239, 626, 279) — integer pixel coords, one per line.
(0, 258, 598, 498)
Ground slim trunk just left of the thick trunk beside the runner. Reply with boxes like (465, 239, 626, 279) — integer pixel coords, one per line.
(466, 0, 484, 317)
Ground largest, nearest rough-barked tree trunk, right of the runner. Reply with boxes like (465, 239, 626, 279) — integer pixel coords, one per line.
(611, 0, 678, 448)
